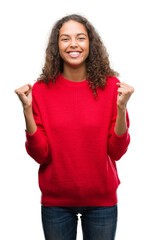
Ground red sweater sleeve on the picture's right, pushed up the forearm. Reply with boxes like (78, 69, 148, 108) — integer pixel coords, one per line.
(108, 81, 130, 160)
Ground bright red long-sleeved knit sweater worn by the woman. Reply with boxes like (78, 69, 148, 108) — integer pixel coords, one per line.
(25, 74, 130, 206)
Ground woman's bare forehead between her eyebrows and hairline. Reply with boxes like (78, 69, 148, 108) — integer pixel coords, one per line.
(59, 20, 87, 35)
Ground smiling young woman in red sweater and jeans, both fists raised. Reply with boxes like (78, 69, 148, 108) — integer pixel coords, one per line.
(15, 15, 134, 240)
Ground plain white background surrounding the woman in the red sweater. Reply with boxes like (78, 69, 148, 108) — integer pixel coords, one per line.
(0, 0, 149, 240)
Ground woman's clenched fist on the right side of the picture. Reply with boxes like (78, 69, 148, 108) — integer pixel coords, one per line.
(117, 82, 134, 109)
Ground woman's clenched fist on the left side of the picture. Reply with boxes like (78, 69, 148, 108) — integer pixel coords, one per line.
(15, 84, 32, 109)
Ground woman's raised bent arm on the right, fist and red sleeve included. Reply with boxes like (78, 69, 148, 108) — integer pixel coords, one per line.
(108, 83, 134, 160)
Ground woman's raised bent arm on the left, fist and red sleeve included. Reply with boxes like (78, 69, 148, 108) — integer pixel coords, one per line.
(15, 84, 50, 164)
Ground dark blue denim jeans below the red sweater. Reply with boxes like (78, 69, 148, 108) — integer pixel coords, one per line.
(42, 205, 117, 240)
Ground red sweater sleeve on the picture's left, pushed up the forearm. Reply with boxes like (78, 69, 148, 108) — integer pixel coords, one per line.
(25, 94, 50, 164)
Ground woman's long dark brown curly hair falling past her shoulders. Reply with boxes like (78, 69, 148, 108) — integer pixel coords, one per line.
(37, 14, 119, 99)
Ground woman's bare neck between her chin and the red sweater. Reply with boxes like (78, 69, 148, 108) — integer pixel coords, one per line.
(62, 64, 87, 82)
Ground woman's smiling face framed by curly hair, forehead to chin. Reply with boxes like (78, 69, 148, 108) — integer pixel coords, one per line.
(58, 20, 89, 67)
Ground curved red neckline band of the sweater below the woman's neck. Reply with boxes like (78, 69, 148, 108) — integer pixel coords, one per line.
(58, 73, 88, 88)
